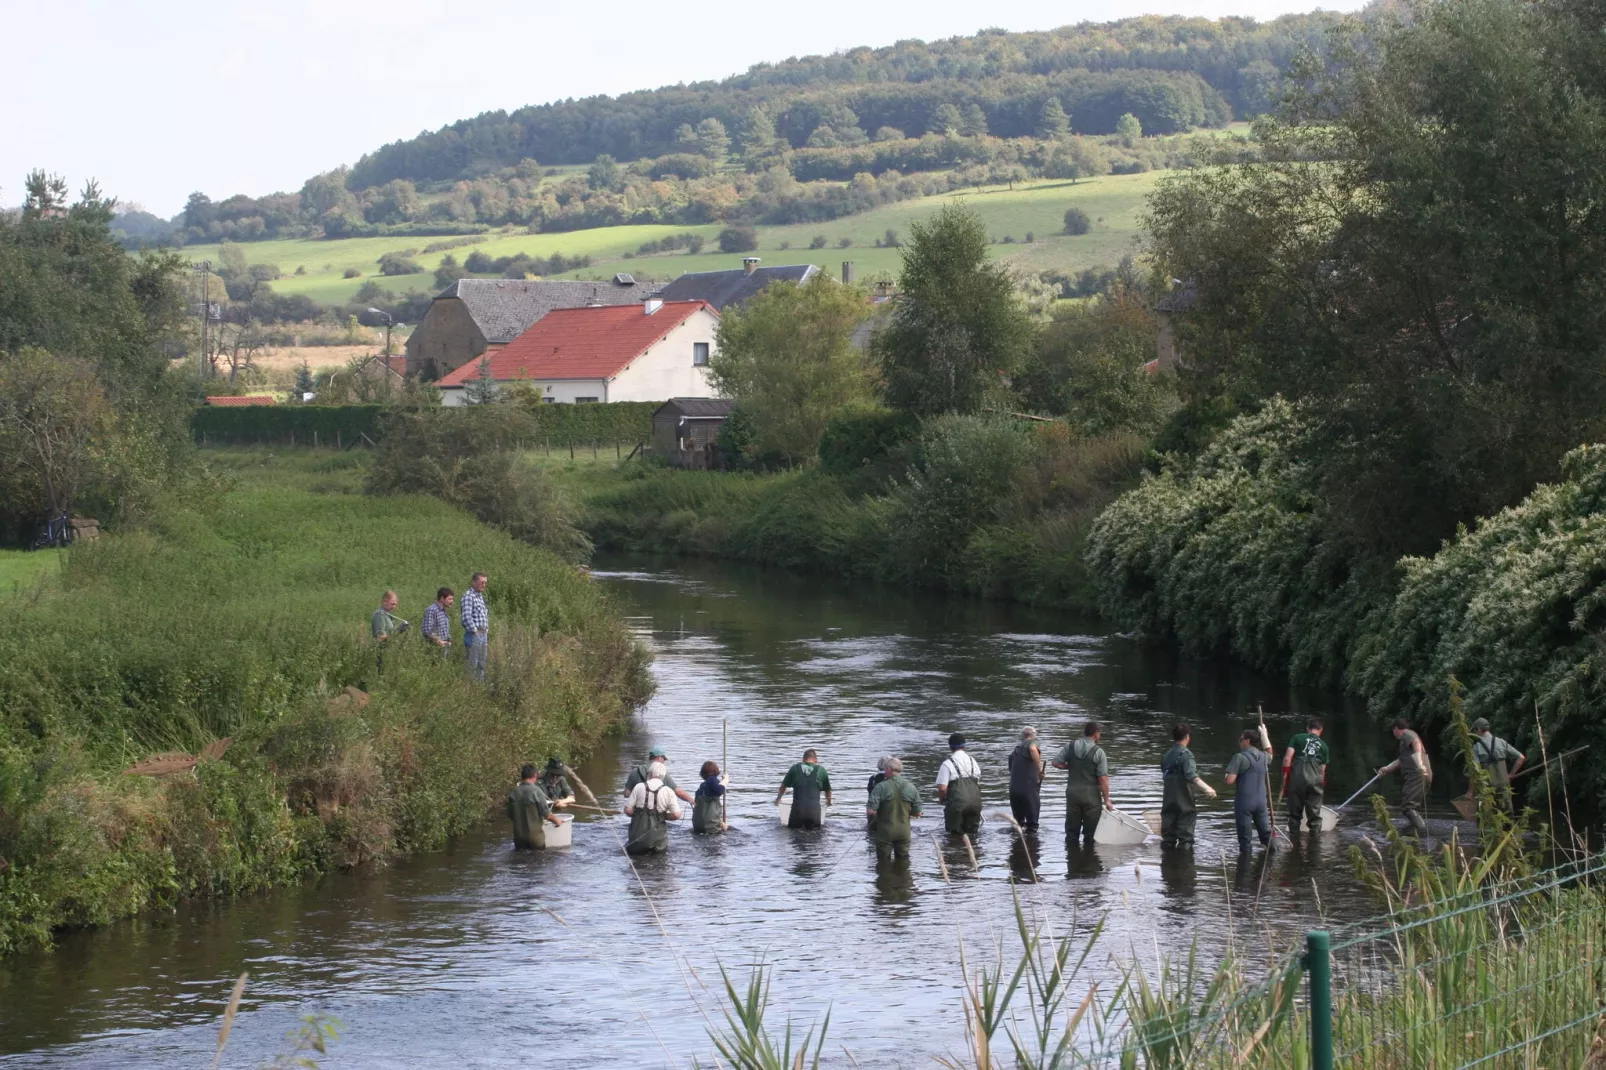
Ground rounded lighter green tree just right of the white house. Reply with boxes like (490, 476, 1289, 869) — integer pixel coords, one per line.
(708, 275, 869, 463)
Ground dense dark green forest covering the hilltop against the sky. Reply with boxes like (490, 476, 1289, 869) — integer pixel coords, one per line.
(347, 11, 1341, 190)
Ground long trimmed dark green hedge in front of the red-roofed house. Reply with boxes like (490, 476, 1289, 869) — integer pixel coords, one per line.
(190, 402, 660, 447)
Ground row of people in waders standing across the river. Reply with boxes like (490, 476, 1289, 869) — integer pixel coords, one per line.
(507, 717, 1526, 861)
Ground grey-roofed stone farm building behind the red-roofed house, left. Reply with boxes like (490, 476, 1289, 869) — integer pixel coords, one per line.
(406, 275, 646, 381)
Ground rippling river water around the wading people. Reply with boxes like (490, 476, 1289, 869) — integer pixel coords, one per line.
(0, 561, 1432, 1070)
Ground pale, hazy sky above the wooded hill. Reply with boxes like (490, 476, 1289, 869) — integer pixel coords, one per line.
(0, 0, 1359, 217)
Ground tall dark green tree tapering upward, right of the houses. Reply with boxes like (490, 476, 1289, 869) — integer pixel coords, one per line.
(870, 204, 1033, 415)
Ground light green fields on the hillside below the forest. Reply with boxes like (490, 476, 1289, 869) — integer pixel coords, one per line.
(185, 172, 1166, 304)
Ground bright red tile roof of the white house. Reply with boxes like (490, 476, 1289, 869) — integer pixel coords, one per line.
(435, 300, 719, 387)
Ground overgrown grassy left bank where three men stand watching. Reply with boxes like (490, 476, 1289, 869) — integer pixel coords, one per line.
(0, 451, 649, 953)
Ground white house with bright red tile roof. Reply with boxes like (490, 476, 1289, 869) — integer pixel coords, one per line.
(435, 299, 719, 405)
